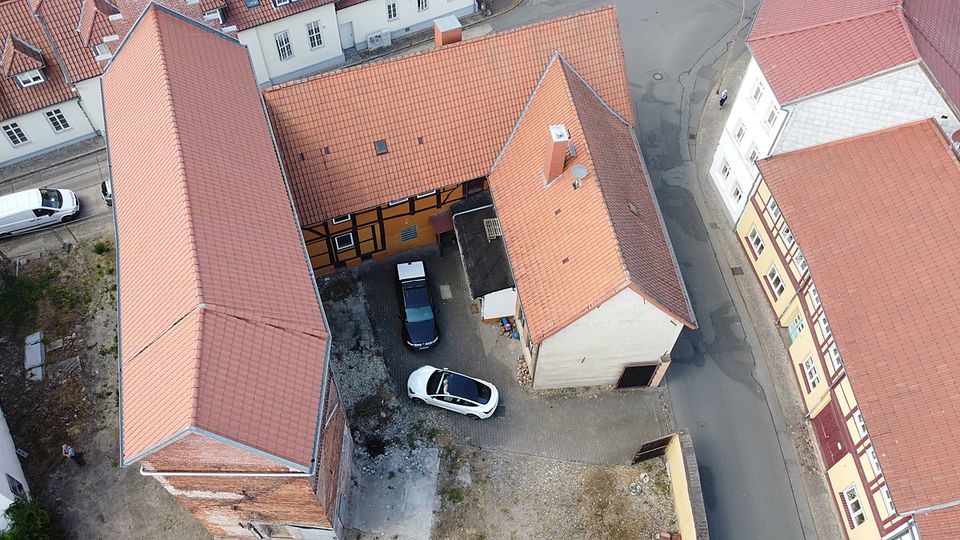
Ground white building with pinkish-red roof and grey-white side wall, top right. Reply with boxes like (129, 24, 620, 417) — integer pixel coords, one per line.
(709, 0, 960, 223)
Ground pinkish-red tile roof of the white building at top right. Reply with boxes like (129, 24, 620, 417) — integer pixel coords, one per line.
(747, 0, 960, 104)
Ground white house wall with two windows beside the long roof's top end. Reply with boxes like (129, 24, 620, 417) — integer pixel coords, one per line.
(237, 3, 343, 84)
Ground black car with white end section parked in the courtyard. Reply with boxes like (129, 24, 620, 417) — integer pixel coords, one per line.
(397, 261, 440, 349)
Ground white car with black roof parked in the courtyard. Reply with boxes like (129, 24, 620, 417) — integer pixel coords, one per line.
(407, 366, 500, 419)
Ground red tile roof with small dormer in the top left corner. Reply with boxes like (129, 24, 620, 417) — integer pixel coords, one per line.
(0, 0, 75, 120)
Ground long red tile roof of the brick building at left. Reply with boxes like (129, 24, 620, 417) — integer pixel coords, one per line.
(103, 7, 327, 469)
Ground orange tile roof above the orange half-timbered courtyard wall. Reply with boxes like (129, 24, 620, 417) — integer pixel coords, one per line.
(264, 7, 633, 225)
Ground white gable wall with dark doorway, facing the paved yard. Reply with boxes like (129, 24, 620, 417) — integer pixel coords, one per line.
(532, 289, 683, 389)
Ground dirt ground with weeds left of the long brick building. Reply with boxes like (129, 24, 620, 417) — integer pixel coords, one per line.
(0, 239, 209, 539)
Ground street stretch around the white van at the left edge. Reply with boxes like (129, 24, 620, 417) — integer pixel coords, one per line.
(0, 151, 113, 258)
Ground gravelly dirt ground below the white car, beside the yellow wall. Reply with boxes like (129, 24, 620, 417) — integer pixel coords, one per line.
(431, 448, 677, 540)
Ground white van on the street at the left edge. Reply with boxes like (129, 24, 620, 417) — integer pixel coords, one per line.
(0, 188, 80, 236)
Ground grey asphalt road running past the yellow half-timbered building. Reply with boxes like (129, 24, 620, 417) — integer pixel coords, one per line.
(490, 0, 816, 539)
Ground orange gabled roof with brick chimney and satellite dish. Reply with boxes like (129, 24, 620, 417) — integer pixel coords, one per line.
(489, 54, 696, 343)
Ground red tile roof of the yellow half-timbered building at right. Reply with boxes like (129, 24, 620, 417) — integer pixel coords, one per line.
(759, 120, 960, 520)
